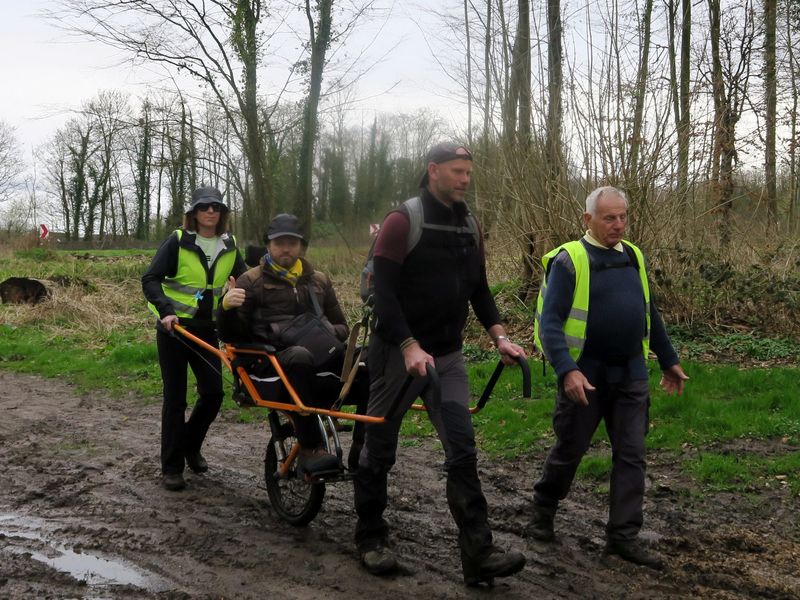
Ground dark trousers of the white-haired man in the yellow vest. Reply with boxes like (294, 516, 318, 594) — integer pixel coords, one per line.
(533, 380, 650, 540)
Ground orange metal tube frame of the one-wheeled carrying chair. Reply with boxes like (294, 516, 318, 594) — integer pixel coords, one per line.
(172, 325, 386, 423)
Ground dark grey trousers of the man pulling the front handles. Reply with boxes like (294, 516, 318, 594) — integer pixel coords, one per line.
(353, 335, 492, 565)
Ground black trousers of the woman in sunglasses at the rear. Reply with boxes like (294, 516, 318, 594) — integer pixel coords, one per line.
(156, 330, 223, 474)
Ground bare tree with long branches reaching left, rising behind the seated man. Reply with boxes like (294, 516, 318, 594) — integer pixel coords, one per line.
(53, 0, 271, 239)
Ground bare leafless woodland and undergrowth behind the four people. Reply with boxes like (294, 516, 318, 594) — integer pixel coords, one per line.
(0, 0, 800, 336)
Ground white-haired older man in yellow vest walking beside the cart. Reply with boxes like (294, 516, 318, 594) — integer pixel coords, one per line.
(526, 187, 688, 569)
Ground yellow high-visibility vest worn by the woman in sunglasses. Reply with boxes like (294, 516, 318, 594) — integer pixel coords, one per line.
(147, 229, 236, 318)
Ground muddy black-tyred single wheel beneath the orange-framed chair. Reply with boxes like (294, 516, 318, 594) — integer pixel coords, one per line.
(264, 438, 325, 527)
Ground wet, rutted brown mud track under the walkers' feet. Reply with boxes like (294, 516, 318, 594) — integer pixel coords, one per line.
(0, 371, 800, 600)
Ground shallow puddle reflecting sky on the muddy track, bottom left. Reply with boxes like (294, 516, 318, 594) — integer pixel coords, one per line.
(0, 514, 171, 592)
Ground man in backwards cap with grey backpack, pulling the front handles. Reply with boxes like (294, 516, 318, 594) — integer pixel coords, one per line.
(353, 143, 525, 585)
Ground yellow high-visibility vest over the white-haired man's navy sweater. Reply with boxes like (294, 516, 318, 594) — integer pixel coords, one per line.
(533, 240, 650, 362)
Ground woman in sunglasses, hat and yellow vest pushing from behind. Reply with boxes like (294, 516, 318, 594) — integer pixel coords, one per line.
(142, 187, 246, 491)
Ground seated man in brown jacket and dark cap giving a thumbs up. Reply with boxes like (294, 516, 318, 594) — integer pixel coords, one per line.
(218, 214, 369, 476)
